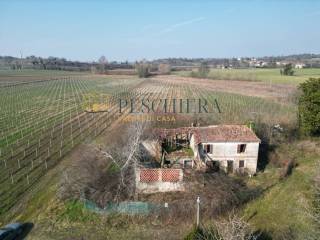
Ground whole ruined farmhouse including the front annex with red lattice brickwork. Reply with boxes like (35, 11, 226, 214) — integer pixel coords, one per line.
(136, 125, 260, 192)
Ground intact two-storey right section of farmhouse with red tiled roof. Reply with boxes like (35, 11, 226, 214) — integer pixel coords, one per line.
(190, 125, 261, 174)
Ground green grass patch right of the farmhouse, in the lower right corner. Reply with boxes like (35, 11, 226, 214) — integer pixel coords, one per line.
(243, 142, 319, 239)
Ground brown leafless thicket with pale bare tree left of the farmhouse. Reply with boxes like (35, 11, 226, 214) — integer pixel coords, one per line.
(58, 123, 144, 206)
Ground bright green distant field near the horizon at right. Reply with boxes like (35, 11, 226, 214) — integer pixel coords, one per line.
(176, 68, 320, 85)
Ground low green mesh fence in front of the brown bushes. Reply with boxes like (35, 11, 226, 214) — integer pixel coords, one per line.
(84, 200, 161, 215)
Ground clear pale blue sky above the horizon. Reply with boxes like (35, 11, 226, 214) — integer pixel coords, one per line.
(0, 0, 320, 61)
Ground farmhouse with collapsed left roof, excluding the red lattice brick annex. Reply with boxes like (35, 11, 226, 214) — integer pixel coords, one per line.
(145, 125, 260, 174)
